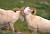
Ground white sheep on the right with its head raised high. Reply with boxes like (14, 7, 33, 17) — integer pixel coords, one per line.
(24, 7, 50, 34)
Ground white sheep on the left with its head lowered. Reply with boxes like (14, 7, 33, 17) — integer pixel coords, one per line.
(0, 8, 24, 32)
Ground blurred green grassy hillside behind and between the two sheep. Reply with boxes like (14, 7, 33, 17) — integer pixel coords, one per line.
(0, 0, 50, 31)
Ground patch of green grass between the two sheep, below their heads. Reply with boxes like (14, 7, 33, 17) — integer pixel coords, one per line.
(14, 20, 28, 31)
